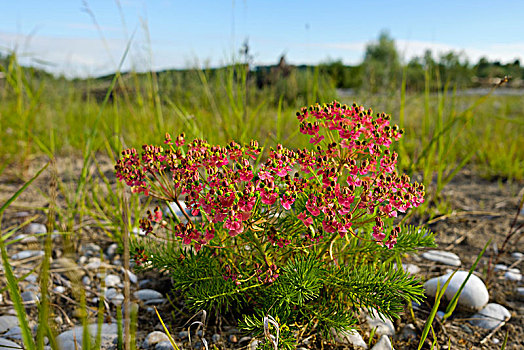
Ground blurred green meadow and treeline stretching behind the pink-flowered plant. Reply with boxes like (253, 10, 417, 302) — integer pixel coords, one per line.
(0, 33, 524, 185)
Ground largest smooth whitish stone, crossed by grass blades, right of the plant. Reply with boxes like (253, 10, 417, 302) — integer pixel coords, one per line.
(424, 271, 489, 311)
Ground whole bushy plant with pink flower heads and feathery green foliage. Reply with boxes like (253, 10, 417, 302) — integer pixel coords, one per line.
(116, 101, 433, 348)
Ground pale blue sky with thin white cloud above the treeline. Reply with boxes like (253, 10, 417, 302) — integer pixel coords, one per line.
(0, 0, 524, 76)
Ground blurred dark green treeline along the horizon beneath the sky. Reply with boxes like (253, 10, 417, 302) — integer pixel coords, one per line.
(0, 32, 524, 102)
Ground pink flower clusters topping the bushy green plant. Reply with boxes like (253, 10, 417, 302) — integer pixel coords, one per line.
(115, 101, 424, 254)
